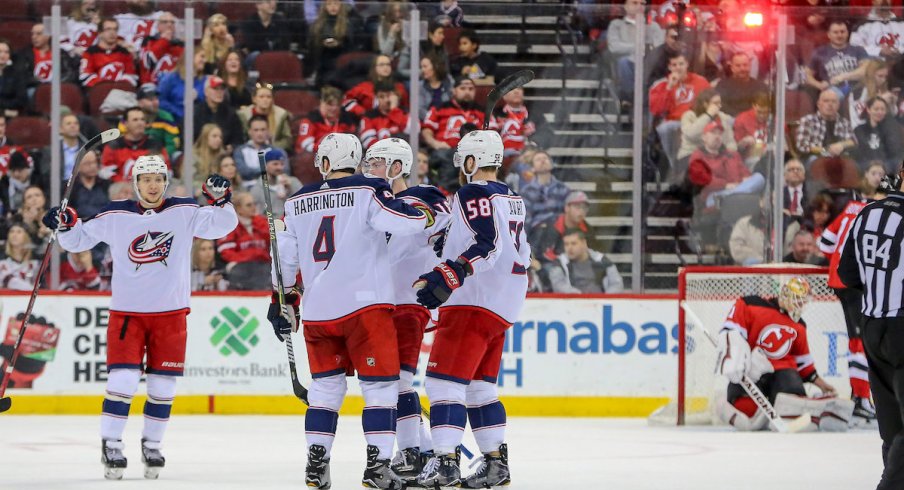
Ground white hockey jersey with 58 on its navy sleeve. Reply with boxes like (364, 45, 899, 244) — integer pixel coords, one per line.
(440, 181, 530, 323)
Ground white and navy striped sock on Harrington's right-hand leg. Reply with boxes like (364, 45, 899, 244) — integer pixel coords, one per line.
(361, 380, 399, 459)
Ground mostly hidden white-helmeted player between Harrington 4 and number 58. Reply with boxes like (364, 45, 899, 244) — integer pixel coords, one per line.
(362, 138, 451, 482)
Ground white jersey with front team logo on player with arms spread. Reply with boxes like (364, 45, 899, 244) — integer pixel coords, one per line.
(59, 197, 238, 314)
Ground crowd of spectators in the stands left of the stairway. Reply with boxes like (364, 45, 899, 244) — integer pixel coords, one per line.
(0, 0, 624, 293)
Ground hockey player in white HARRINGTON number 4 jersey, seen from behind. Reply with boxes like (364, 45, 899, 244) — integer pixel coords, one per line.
(267, 133, 433, 489)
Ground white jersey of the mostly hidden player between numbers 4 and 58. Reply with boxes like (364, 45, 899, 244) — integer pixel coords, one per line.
(389, 185, 452, 306)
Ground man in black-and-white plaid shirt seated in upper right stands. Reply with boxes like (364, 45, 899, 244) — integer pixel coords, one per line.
(796, 89, 856, 163)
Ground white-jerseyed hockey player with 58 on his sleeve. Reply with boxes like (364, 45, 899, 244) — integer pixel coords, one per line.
(415, 131, 530, 488)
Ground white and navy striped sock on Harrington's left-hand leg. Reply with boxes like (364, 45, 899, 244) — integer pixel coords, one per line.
(304, 374, 348, 457)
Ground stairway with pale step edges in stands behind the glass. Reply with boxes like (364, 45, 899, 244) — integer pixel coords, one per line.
(459, 0, 696, 292)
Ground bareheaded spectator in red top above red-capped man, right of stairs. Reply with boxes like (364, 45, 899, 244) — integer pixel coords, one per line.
(650, 53, 709, 171)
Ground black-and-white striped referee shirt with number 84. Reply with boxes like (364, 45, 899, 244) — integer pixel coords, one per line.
(838, 192, 904, 318)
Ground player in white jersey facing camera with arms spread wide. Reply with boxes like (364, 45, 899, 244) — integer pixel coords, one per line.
(44, 155, 238, 479)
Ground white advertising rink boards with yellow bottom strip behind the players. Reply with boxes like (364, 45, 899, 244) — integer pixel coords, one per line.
(0, 293, 856, 416)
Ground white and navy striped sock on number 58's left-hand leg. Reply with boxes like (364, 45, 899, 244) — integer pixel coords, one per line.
(424, 377, 468, 454)
